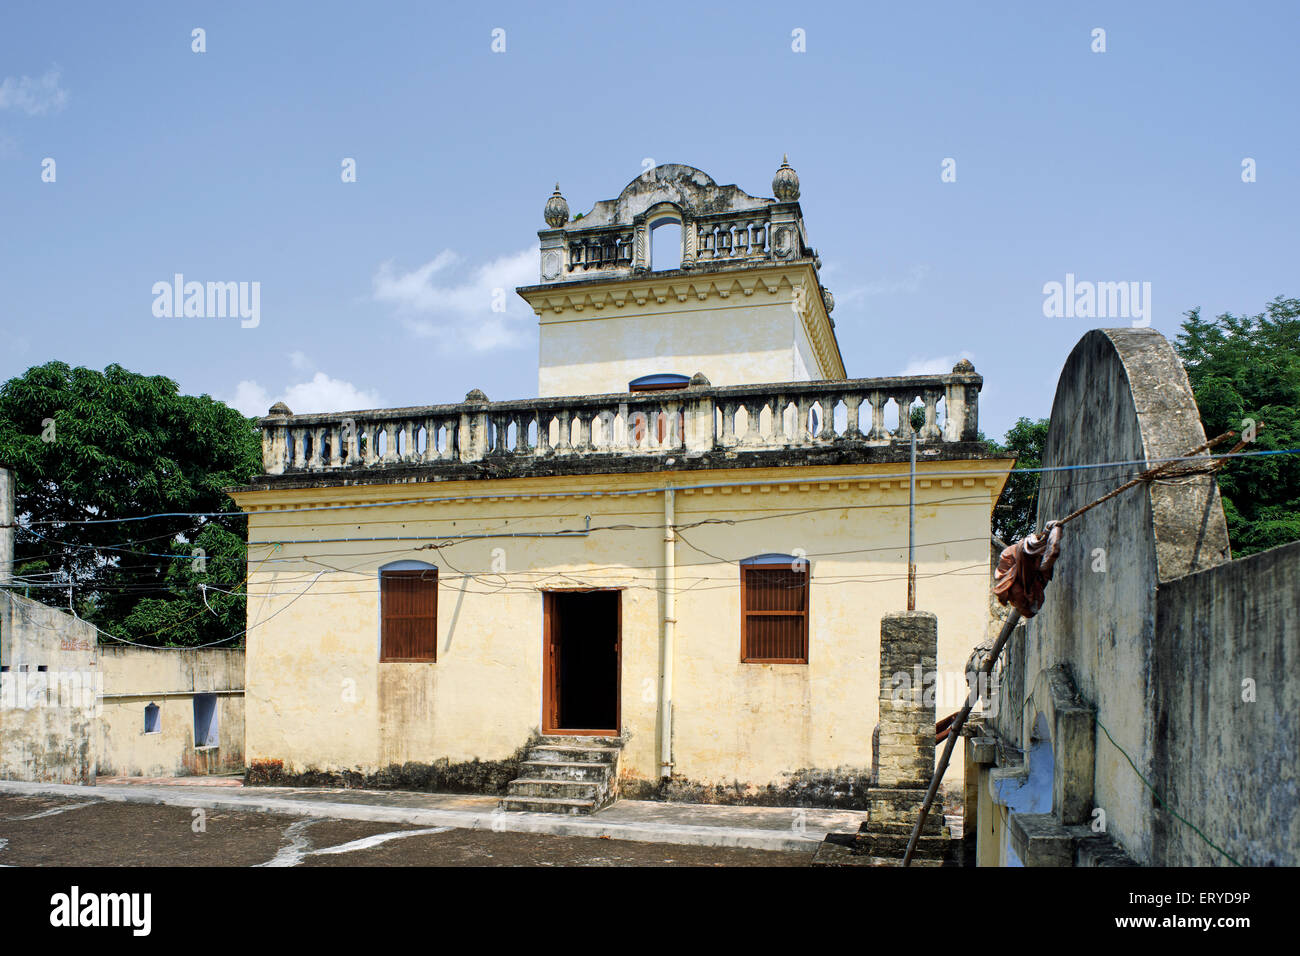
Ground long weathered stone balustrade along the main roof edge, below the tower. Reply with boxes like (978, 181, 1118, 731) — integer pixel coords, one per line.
(259, 362, 983, 475)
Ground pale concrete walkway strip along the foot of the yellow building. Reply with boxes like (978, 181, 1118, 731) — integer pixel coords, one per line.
(0, 778, 863, 852)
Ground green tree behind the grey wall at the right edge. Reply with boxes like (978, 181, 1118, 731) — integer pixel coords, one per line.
(1175, 295, 1300, 557)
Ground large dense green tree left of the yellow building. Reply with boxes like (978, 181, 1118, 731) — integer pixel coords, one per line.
(0, 362, 260, 646)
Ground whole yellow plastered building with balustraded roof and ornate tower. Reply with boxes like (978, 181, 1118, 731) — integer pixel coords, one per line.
(231, 164, 1011, 812)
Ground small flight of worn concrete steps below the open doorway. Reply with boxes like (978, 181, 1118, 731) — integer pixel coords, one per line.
(501, 735, 623, 814)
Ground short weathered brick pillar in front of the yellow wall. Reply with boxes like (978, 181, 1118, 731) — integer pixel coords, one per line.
(879, 611, 939, 790)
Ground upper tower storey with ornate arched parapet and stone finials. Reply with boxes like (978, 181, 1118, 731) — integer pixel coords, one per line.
(519, 161, 845, 397)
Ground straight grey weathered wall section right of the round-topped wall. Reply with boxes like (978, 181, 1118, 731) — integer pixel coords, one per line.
(1154, 541, 1300, 866)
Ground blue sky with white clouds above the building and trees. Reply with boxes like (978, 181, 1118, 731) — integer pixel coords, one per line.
(0, 0, 1300, 436)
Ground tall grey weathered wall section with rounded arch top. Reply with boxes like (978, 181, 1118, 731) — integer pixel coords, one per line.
(1024, 329, 1229, 868)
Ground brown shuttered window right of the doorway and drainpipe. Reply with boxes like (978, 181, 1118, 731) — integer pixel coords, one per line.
(740, 563, 810, 663)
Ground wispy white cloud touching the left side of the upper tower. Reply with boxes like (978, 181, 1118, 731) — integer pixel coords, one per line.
(373, 247, 537, 351)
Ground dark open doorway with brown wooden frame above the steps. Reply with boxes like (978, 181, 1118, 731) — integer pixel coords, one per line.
(542, 591, 623, 736)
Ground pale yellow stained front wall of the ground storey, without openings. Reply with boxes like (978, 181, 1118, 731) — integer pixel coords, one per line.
(235, 460, 1009, 788)
